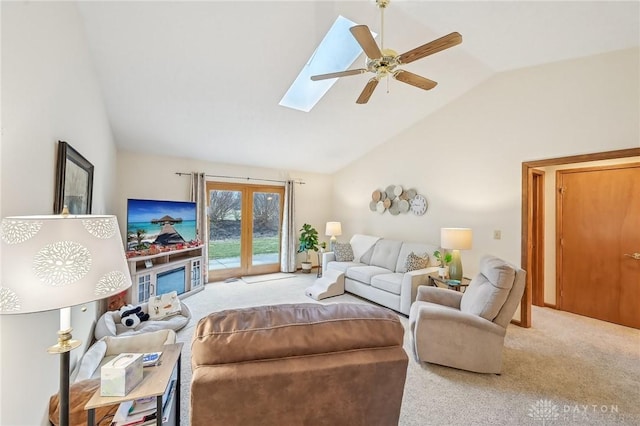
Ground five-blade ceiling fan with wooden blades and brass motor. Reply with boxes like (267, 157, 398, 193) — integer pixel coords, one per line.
(311, 0, 462, 104)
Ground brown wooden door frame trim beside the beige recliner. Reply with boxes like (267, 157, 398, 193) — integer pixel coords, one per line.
(513, 148, 640, 328)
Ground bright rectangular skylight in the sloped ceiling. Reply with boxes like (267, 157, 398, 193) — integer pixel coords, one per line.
(280, 16, 377, 112)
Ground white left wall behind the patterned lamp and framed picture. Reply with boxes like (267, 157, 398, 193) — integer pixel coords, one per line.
(0, 2, 116, 426)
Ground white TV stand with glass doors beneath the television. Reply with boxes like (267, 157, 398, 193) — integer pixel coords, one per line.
(127, 245, 205, 305)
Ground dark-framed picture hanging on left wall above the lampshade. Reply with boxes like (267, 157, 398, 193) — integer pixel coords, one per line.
(53, 141, 93, 214)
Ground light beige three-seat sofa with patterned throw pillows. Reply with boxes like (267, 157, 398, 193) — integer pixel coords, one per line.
(322, 234, 439, 315)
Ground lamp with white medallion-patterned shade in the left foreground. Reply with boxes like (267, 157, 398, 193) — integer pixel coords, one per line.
(0, 215, 131, 426)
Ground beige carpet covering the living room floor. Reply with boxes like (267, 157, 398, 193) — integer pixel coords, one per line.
(178, 274, 640, 426)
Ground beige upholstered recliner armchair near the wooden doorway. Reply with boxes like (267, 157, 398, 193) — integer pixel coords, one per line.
(409, 256, 525, 374)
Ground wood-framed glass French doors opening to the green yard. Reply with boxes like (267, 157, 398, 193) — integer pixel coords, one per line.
(207, 182, 284, 281)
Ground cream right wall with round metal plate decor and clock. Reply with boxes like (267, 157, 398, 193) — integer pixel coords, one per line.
(333, 49, 640, 276)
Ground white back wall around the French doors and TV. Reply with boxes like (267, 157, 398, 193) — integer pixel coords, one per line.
(117, 150, 333, 263)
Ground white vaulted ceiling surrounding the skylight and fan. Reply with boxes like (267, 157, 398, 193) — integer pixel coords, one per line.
(78, 0, 640, 172)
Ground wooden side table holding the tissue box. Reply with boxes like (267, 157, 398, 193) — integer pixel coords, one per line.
(84, 343, 183, 426)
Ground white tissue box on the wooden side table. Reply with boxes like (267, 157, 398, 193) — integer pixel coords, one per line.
(100, 353, 142, 396)
